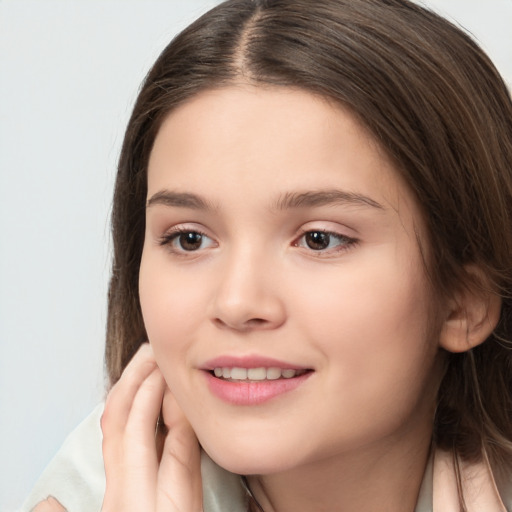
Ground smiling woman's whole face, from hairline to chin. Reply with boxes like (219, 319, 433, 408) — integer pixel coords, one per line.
(140, 86, 444, 474)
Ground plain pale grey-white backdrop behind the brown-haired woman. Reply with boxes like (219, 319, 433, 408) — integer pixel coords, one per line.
(0, 0, 512, 512)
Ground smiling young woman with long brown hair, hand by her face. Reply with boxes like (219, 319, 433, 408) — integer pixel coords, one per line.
(26, 0, 512, 512)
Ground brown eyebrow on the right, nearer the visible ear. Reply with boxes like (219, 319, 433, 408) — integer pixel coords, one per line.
(275, 189, 386, 210)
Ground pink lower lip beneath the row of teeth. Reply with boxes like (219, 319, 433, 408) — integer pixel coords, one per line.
(204, 372, 313, 405)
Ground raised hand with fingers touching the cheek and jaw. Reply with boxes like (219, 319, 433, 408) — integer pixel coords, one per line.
(101, 343, 203, 512)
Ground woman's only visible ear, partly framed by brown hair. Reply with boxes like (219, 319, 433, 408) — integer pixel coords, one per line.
(439, 266, 501, 352)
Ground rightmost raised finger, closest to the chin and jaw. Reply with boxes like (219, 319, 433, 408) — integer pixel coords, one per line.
(157, 390, 203, 512)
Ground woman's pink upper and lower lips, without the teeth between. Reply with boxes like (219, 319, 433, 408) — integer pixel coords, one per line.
(202, 356, 313, 405)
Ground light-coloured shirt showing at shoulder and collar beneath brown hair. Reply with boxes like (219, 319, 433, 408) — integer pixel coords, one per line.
(20, 404, 512, 512)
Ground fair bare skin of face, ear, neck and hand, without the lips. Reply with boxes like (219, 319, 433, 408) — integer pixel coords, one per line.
(38, 84, 501, 512)
